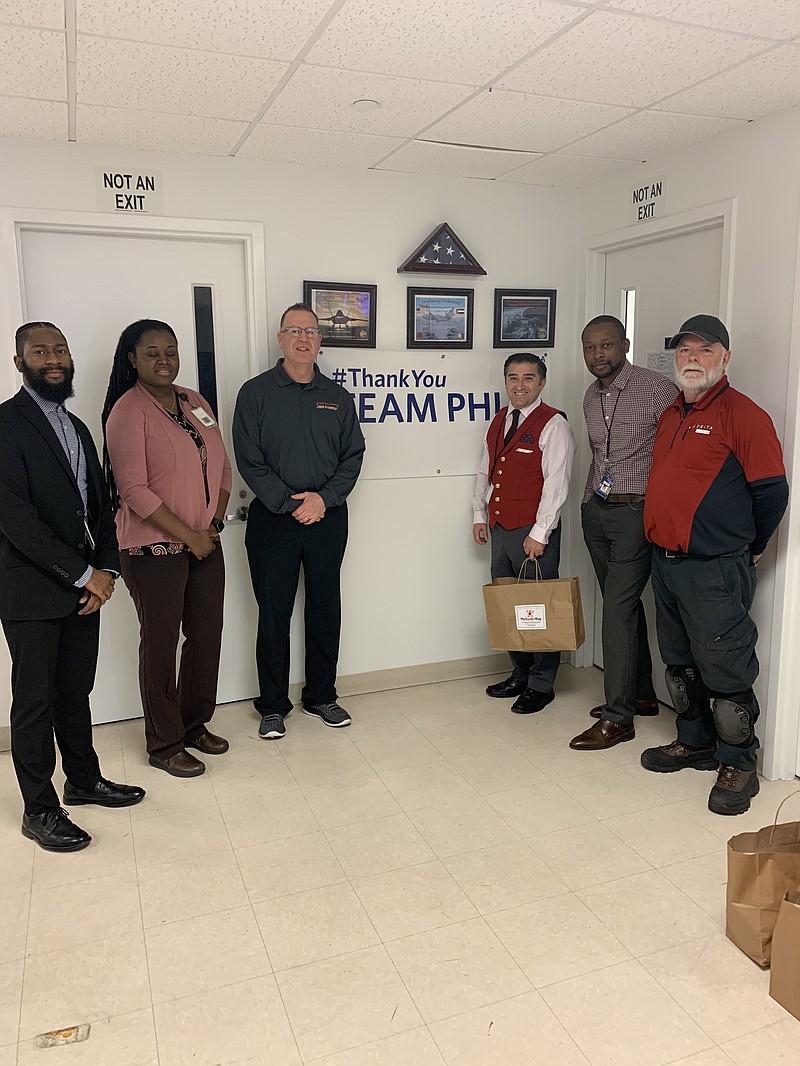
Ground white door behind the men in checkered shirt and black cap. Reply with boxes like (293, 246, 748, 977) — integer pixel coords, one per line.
(594, 225, 722, 702)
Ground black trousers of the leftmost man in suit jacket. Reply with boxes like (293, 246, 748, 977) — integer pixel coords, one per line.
(2, 608, 100, 814)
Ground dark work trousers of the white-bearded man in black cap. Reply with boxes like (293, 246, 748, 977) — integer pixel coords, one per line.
(653, 548, 758, 770)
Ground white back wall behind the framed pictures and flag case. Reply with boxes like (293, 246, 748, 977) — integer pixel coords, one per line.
(0, 134, 583, 699)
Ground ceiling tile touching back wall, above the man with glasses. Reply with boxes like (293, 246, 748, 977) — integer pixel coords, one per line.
(237, 123, 403, 168)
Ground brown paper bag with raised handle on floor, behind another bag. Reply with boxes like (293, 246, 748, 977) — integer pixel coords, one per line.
(725, 793, 800, 967)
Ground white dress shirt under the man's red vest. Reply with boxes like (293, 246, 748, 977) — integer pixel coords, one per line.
(473, 398, 575, 544)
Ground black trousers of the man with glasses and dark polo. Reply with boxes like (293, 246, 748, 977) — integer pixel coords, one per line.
(244, 500, 348, 714)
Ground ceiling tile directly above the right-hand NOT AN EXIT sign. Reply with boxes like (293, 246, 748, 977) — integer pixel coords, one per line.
(570, 111, 743, 162)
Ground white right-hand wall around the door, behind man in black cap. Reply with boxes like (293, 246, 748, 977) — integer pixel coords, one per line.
(580, 109, 800, 776)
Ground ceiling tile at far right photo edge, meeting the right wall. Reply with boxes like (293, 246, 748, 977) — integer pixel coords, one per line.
(656, 45, 800, 118)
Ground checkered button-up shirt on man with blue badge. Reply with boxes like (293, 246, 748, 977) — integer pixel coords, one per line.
(582, 360, 677, 503)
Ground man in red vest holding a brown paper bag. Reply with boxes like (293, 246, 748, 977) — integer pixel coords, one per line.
(473, 352, 575, 714)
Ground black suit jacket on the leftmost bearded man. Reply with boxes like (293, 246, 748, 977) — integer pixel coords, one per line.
(0, 389, 119, 621)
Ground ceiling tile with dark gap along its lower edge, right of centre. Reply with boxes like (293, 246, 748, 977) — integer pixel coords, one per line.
(425, 90, 630, 152)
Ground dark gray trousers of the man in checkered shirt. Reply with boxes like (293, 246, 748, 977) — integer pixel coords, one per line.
(580, 495, 656, 723)
